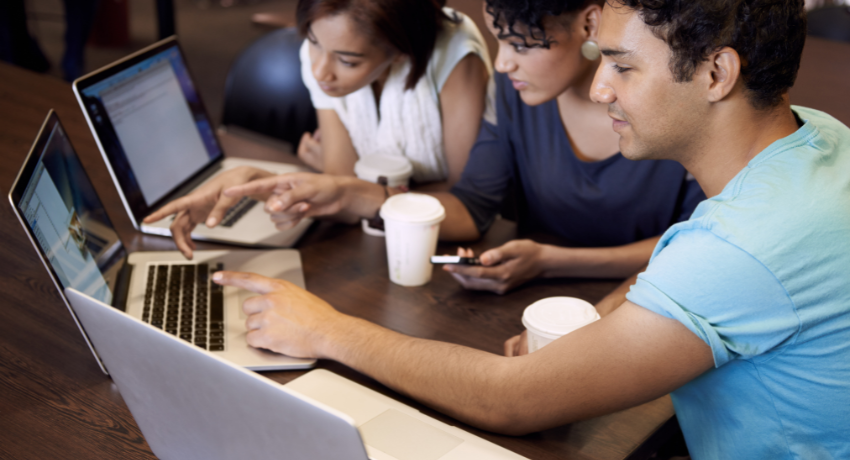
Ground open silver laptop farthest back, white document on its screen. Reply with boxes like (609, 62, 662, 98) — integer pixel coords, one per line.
(73, 37, 310, 247)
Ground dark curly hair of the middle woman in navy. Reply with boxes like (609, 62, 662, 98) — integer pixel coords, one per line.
(486, 0, 603, 48)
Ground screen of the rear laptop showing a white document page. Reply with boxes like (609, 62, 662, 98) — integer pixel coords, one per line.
(76, 39, 222, 219)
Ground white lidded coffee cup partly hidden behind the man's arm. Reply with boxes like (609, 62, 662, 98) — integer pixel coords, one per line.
(522, 297, 599, 353)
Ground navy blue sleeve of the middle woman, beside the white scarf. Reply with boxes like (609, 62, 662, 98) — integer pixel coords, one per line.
(450, 113, 514, 234)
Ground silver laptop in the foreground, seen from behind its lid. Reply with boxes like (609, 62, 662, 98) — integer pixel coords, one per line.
(66, 289, 523, 460)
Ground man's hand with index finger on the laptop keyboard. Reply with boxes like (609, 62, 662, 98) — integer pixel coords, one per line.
(213, 271, 346, 358)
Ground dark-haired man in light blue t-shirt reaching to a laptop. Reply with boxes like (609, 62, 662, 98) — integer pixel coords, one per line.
(209, 0, 850, 460)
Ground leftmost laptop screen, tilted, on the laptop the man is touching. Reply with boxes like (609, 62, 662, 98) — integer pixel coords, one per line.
(11, 114, 126, 304)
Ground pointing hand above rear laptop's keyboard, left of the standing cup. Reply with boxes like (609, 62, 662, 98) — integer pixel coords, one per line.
(224, 173, 346, 230)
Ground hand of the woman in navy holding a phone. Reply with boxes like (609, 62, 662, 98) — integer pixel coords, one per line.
(443, 240, 543, 294)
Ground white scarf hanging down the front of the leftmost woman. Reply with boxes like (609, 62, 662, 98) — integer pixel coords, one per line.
(334, 60, 448, 183)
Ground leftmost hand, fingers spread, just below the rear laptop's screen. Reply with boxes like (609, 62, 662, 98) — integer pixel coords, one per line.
(144, 166, 271, 259)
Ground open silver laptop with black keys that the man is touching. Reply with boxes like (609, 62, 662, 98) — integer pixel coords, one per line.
(9, 110, 314, 372)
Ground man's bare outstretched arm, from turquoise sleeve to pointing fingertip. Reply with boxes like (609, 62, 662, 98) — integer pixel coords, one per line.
(214, 272, 714, 435)
